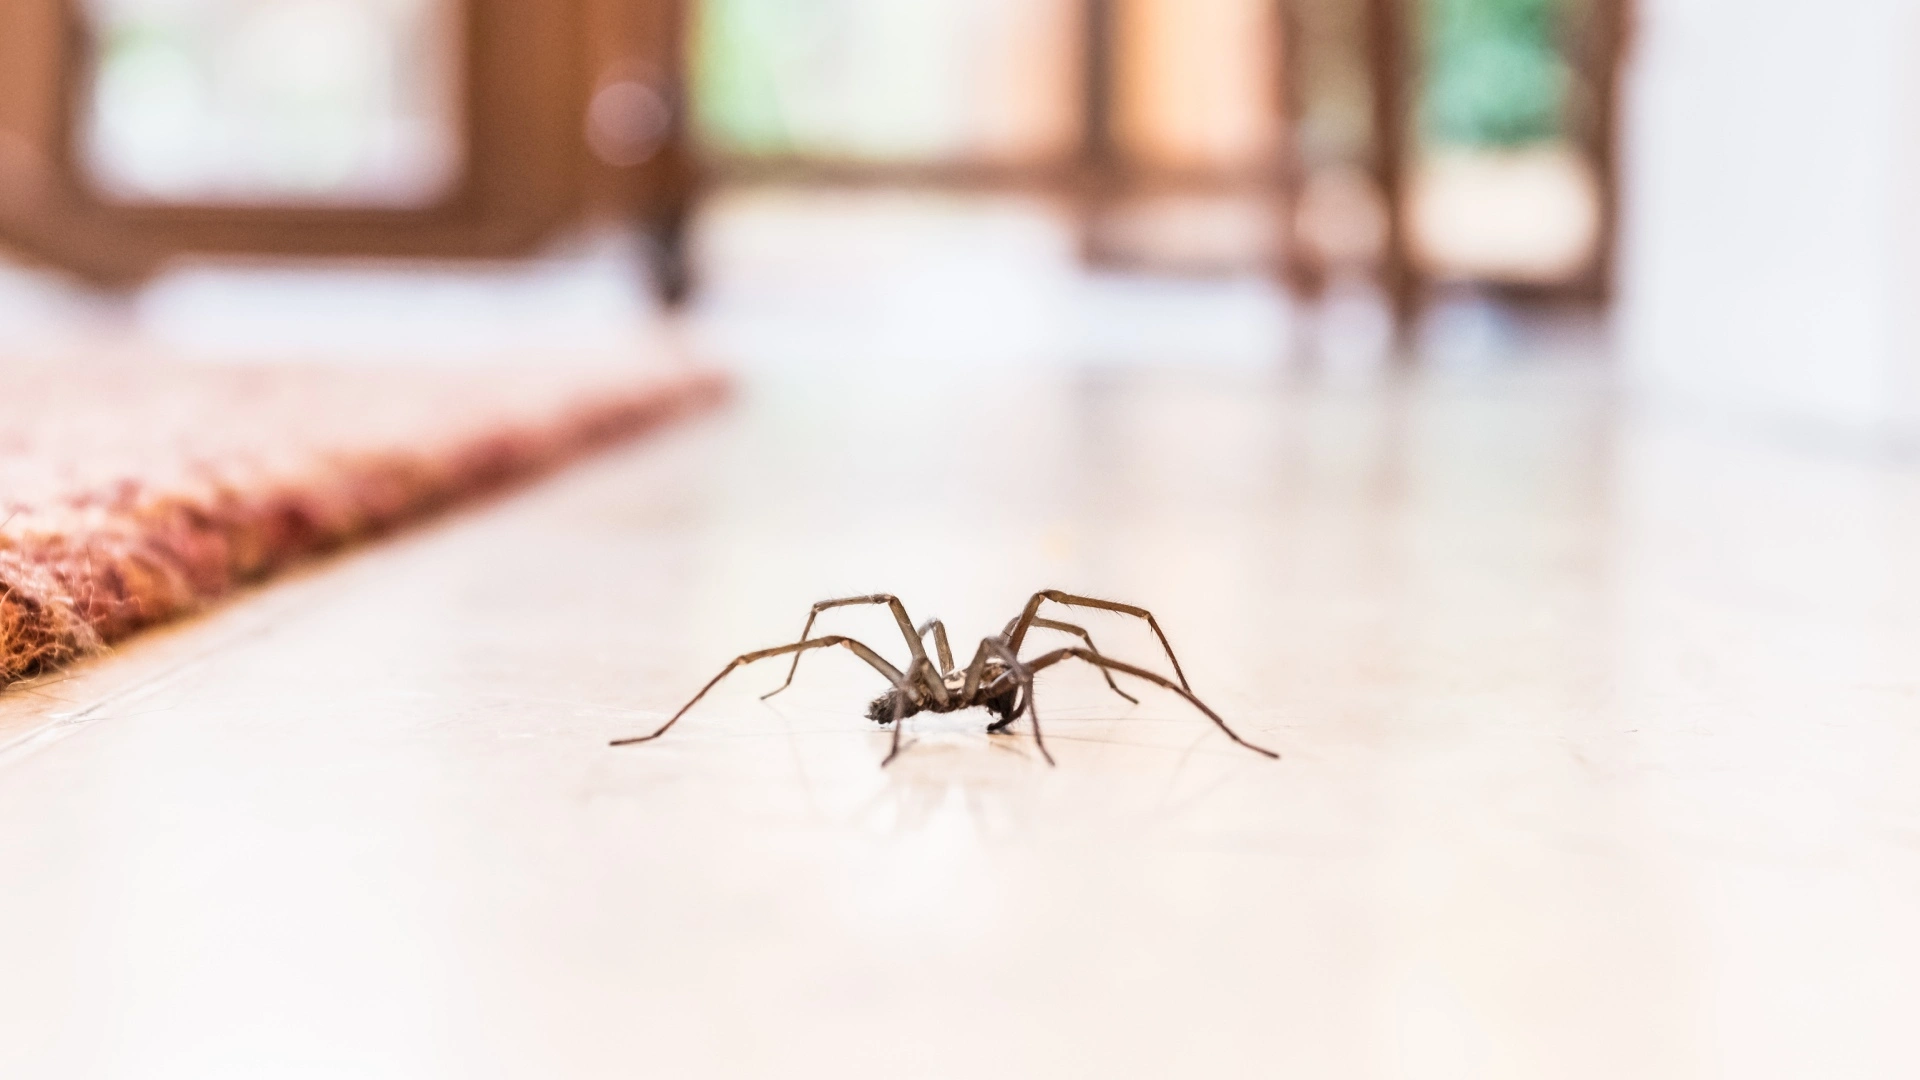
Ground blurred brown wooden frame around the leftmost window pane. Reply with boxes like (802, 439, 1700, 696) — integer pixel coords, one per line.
(0, 0, 588, 282)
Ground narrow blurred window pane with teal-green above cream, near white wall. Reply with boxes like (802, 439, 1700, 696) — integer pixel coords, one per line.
(1405, 0, 1605, 284)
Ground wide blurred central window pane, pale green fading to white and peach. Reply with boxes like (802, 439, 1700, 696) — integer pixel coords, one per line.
(693, 0, 1081, 163)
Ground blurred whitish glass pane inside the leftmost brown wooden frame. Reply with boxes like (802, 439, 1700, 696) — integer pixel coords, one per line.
(77, 0, 465, 208)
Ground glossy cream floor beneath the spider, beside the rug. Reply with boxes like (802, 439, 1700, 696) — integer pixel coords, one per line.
(0, 357, 1920, 1078)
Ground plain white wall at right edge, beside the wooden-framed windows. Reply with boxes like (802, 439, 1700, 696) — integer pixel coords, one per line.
(1619, 0, 1920, 438)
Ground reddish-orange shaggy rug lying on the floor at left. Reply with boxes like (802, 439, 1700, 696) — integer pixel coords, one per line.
(0, 363, 726, 686)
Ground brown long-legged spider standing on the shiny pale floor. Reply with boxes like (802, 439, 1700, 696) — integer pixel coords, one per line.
(611, 588, 1279, 767)
